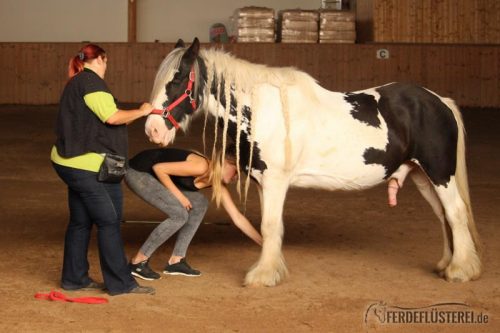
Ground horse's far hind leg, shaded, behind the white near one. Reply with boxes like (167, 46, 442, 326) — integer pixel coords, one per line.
(410, 167, 453, 276)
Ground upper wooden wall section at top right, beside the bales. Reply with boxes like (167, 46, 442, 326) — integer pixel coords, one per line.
(356, 0, 500, 44)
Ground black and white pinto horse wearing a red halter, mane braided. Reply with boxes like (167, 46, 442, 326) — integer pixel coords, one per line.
(146, 38, 481, 286)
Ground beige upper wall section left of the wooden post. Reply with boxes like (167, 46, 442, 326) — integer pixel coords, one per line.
(0, 0, 127, 42)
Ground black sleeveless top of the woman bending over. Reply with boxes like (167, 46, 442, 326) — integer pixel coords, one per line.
(129, 148, 201, 191)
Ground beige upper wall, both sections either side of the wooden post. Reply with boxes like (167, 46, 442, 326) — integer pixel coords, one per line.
(0, 0, 321, 42)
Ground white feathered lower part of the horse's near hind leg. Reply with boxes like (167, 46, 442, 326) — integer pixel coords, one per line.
(434, 177, 481, 282)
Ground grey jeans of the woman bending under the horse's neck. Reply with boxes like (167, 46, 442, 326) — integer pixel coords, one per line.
(125, 169, 208, 258)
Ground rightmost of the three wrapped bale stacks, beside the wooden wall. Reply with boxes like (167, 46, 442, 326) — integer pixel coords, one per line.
(319, 10, 356, 43)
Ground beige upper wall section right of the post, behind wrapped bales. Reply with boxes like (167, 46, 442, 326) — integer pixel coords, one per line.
(136, 0, 321, 42)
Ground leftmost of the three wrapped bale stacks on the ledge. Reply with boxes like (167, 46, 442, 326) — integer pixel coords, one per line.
(232, 6, 276, 43)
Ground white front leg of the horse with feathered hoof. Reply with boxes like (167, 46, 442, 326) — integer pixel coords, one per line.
(245, 175, 288, 287)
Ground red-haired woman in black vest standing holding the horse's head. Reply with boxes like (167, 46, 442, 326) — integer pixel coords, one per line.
(51, 44, 154, 295)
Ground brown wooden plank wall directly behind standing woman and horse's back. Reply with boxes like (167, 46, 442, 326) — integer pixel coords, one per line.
(0, 43, 500, 107)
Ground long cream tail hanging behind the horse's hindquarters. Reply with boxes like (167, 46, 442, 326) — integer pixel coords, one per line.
(443, 98, 482, 254)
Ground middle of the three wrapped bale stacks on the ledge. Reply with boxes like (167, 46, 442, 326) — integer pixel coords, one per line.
(278, 9, 318, 43)
